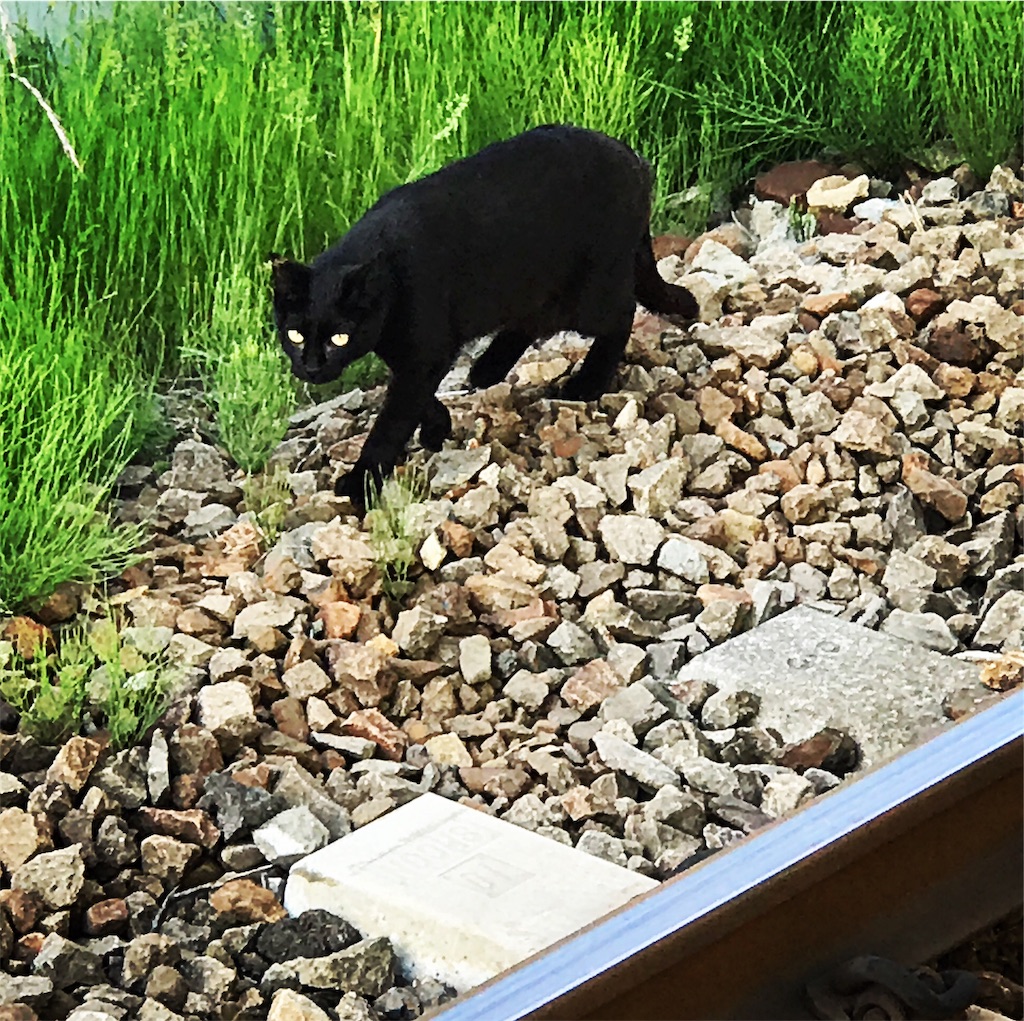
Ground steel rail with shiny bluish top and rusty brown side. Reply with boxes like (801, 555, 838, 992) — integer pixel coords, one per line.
(431, 691, 1024, 1021)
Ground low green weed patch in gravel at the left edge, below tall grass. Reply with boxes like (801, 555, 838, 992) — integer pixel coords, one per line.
(0, 614, 179, 751)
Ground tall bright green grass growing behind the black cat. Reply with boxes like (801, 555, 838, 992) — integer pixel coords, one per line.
(0, 0, 1024, 606)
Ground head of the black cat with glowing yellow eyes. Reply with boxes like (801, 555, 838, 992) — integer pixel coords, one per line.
(269, 255, 383, 383)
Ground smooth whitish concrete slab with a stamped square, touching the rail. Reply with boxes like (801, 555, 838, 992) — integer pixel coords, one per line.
(285, 794, 658, 991)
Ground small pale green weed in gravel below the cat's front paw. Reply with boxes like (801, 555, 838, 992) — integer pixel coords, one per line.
(366, 466, 427, 602)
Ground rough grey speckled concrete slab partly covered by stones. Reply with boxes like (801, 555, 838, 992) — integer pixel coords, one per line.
(678, 606, 978, 765)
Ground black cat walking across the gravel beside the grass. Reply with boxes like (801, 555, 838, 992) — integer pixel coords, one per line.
(271, 125, 697, 507)
